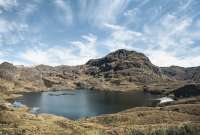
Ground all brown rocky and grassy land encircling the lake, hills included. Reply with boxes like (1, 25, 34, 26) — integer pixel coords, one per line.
(0, 49, 200, 135)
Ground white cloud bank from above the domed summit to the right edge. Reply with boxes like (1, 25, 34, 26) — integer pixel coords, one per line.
(103, 11, 200, 67)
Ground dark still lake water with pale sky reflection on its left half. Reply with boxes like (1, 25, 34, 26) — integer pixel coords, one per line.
(15, 90, 161, 119)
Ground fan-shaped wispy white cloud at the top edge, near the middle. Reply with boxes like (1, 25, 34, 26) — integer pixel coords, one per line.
(79, 0, 129, 26)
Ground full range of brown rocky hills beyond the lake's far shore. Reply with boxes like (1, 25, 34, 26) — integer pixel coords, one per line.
(0, 49, 200, 93)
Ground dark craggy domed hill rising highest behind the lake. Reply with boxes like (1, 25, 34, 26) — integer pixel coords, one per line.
(86, 49, 162, 83)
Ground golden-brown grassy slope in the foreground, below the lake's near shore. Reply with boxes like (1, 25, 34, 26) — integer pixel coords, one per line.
(0, 100, 200, 135)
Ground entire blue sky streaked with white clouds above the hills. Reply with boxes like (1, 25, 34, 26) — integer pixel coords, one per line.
(0, 0, 200, 67)
